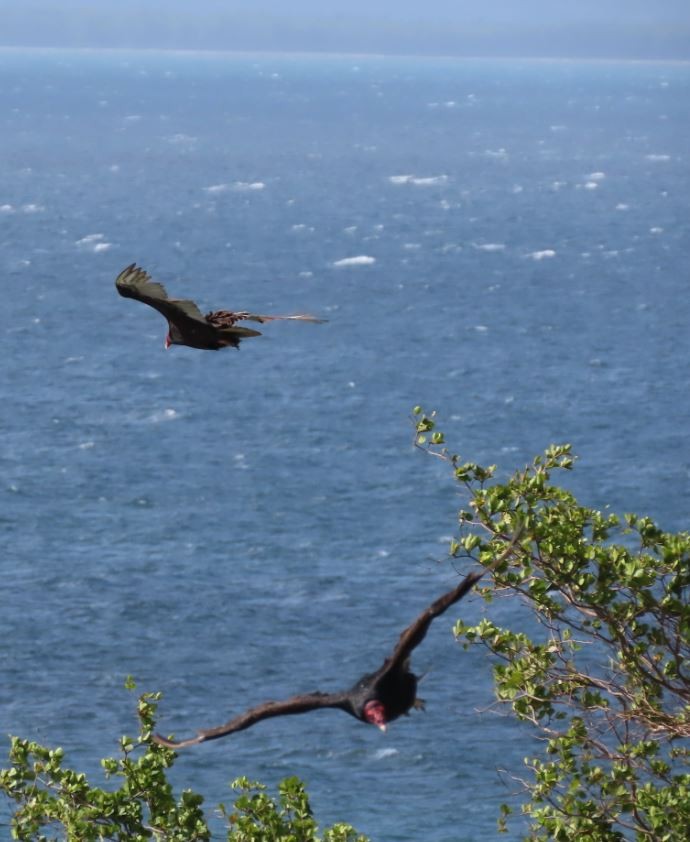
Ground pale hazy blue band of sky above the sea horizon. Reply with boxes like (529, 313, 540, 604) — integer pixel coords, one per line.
(0, 0, 690, 59)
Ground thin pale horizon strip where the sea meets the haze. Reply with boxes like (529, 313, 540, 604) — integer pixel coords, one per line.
(0, 43, 690, 65)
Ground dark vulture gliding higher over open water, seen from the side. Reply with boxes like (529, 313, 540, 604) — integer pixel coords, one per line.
(115, 263, 324, 351)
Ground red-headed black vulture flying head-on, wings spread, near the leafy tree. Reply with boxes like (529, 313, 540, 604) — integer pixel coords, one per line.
(153, 535, 518, 749)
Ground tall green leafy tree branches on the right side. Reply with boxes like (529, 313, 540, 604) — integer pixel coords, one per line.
(414, 407, 690, 842)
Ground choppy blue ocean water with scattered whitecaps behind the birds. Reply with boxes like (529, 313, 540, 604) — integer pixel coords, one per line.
(0, 51, 690, 842)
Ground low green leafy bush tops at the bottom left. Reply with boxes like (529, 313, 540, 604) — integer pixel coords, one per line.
(0, 682, 366, 842)
